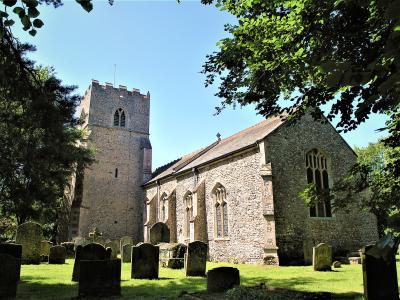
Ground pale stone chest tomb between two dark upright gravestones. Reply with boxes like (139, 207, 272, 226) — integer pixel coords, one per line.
(158, 243, 187, 269)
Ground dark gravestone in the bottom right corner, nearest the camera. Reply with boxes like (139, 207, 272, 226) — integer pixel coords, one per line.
(362, 245, 399, 300)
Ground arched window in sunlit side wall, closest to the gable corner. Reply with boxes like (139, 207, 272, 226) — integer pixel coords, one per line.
(213, 184, 229, 238)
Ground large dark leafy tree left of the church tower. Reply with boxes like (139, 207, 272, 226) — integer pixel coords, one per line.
(0, 27, 93, 240)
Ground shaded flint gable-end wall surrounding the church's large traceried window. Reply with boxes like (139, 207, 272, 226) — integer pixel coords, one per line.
(265, 115, 378, 265)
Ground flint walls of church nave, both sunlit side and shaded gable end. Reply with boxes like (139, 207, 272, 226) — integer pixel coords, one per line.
(145, 115, 378, 265)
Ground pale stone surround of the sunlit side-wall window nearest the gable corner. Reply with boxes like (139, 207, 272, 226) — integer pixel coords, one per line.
(211, 182, 230, 241)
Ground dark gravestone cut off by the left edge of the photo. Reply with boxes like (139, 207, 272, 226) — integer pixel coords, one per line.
(0, 253, 20, 299)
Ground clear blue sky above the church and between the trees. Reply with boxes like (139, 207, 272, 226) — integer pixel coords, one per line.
(13, 0, 385, 168)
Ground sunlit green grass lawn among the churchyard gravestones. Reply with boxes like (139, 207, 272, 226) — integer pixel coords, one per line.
(17, 259, 400, 299)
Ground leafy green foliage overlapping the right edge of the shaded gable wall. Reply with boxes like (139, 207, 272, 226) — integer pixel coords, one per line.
(333, 142, 400, 236)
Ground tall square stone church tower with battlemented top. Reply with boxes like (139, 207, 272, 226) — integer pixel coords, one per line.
(69, 80, 151, 242)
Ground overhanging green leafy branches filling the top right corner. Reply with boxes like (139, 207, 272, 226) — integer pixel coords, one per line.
(202, 0, 400, 131)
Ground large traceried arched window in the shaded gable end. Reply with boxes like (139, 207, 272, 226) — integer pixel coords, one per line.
(306, 149, 332, 217)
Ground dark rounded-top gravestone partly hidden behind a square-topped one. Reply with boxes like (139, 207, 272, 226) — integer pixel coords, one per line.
(72, 243, 111, 281)
